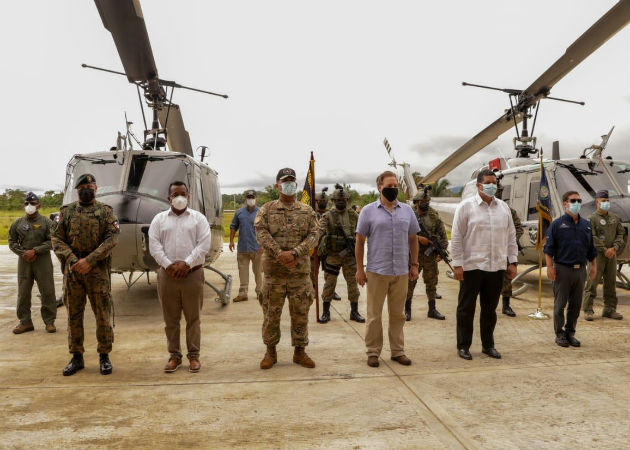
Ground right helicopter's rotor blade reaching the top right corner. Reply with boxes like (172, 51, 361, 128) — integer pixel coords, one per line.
(520, 0, 630, 105)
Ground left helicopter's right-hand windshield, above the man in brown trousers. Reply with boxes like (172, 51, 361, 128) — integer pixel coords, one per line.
(127, 155, 190, 199)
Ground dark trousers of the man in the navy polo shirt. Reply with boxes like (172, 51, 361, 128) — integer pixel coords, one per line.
(553, 264, 586, 336)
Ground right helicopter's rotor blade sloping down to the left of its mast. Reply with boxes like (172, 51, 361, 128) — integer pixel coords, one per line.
(422, 113, 523, 184)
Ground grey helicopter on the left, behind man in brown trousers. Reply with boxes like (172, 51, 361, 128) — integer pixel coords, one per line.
(57, 0, 232, 305)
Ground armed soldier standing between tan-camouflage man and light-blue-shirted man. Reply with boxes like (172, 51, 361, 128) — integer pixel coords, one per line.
(318, 184, 365, 323)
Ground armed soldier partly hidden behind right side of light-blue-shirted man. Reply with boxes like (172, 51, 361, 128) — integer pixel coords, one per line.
(405, 188, 448, 321)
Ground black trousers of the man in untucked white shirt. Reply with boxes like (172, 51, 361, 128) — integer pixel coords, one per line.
(457, 270, 505, 349)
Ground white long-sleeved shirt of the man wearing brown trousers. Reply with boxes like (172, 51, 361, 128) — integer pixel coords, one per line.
(149, 208, 210, 269)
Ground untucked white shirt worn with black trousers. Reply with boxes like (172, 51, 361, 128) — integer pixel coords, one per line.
(451, 193, 518, 272)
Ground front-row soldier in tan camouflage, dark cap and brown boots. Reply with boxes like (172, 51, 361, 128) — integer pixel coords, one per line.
(254, 168, 319, 369)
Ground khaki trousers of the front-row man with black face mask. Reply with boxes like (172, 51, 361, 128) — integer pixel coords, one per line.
(365, 272, 409, 357)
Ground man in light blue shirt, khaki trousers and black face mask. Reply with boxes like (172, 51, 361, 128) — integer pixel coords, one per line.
(355, 171, 420, 367)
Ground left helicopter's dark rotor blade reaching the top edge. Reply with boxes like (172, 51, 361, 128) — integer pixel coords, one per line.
(94, 0, 158, 83)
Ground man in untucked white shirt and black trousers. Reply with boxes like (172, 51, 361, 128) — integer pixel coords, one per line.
(451, 169, 518, 360)
